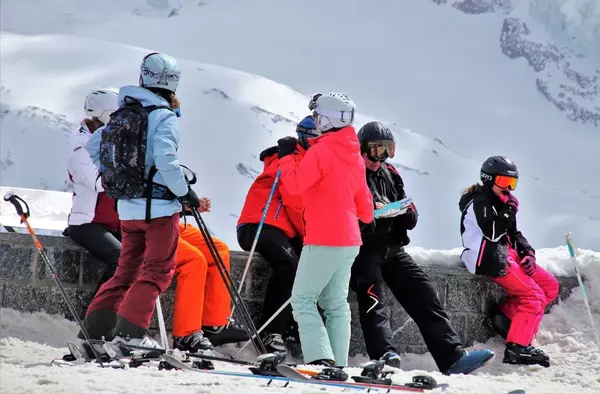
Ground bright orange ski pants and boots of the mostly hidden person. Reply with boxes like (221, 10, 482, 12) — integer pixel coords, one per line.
(172, 219, 249, 352)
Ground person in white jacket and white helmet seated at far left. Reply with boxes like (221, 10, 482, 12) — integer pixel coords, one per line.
(64, 88, 121, 294)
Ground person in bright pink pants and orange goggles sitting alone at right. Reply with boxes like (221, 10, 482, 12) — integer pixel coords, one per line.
(459, 156, 559, 367)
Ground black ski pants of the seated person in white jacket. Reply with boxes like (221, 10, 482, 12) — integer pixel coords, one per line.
(67, 223, 121, 295)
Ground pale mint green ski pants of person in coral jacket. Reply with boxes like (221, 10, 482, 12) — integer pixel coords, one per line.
(291, 245, 360, 367)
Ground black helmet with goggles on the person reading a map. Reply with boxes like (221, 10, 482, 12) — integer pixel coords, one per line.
(358, 121, 396, 162)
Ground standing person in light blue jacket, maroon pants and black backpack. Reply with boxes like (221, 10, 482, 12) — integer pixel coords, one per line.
(80, 53, 201, 347)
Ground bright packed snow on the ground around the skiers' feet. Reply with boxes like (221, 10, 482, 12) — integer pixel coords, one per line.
(0, 248, 600, 394)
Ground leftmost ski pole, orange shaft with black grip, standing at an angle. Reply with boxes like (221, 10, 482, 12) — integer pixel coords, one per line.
(4, 191, 103, 366)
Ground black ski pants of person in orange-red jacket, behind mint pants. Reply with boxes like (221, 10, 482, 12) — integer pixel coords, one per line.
(237, 224, 302, 335)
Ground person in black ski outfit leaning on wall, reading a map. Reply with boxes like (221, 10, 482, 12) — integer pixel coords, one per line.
(350, 122, 494, 374)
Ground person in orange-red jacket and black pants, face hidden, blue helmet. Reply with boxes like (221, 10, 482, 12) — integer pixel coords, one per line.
(236, 115, 317, 352)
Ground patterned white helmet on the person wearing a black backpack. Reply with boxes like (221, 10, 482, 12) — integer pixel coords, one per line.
(140, 52, 181, 92)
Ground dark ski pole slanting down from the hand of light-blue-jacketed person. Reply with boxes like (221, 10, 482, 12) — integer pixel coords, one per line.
(190, 208, 267, 354)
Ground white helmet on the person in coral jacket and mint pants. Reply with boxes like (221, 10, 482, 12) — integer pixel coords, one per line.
(309, 92, 356, 133)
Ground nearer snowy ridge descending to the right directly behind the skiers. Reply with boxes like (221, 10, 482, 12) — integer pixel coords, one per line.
(0, 33, 600, 248)
